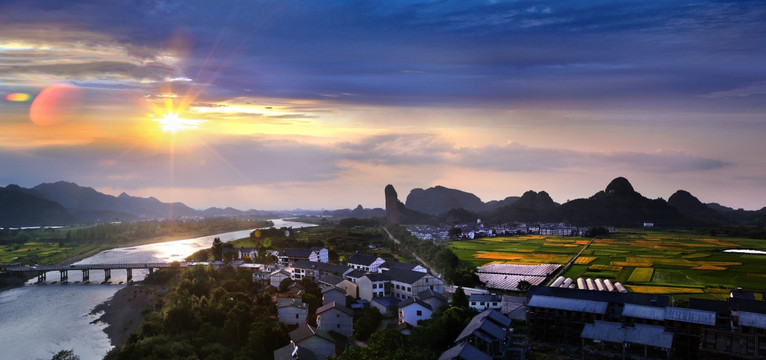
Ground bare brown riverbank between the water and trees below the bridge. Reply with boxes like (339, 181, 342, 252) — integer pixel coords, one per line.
(91, 284, 167, 346)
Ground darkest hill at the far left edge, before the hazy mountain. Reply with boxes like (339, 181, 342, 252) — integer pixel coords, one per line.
(0, 185, 75, 227)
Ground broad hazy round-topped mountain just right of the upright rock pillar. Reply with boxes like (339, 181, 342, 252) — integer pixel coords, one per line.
(405, 186, 519, 215)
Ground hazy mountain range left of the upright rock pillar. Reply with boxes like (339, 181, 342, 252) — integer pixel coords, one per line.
(0, 181, 385, 227)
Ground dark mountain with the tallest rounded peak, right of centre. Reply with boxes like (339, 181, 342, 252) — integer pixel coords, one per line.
(557, 177, 686, 226)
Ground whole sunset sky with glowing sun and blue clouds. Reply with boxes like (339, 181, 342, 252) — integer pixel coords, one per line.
(0, 0, 766, 210)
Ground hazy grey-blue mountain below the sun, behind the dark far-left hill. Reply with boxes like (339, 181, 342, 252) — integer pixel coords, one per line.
(33, 181, 200, 221)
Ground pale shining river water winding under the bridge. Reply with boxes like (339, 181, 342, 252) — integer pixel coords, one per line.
(0, 219, 313, 360)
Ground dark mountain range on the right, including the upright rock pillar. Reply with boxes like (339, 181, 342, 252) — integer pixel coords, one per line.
(385, 177, 766, 226)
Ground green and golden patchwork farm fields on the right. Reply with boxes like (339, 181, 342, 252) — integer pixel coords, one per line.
(450, 229, 766, 299)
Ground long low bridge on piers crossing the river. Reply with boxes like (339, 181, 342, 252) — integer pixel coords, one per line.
(4, 262, 189, 283)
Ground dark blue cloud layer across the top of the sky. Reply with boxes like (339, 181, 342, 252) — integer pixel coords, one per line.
(3, 0, 766, 106)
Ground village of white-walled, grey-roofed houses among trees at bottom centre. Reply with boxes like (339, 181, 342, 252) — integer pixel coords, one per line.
(211, 243, 528, 360)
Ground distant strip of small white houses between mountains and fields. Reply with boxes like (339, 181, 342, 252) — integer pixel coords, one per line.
(408, 220, 614, 241)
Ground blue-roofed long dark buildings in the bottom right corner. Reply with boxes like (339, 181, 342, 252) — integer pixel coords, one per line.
(526, 287, 766, 359)
